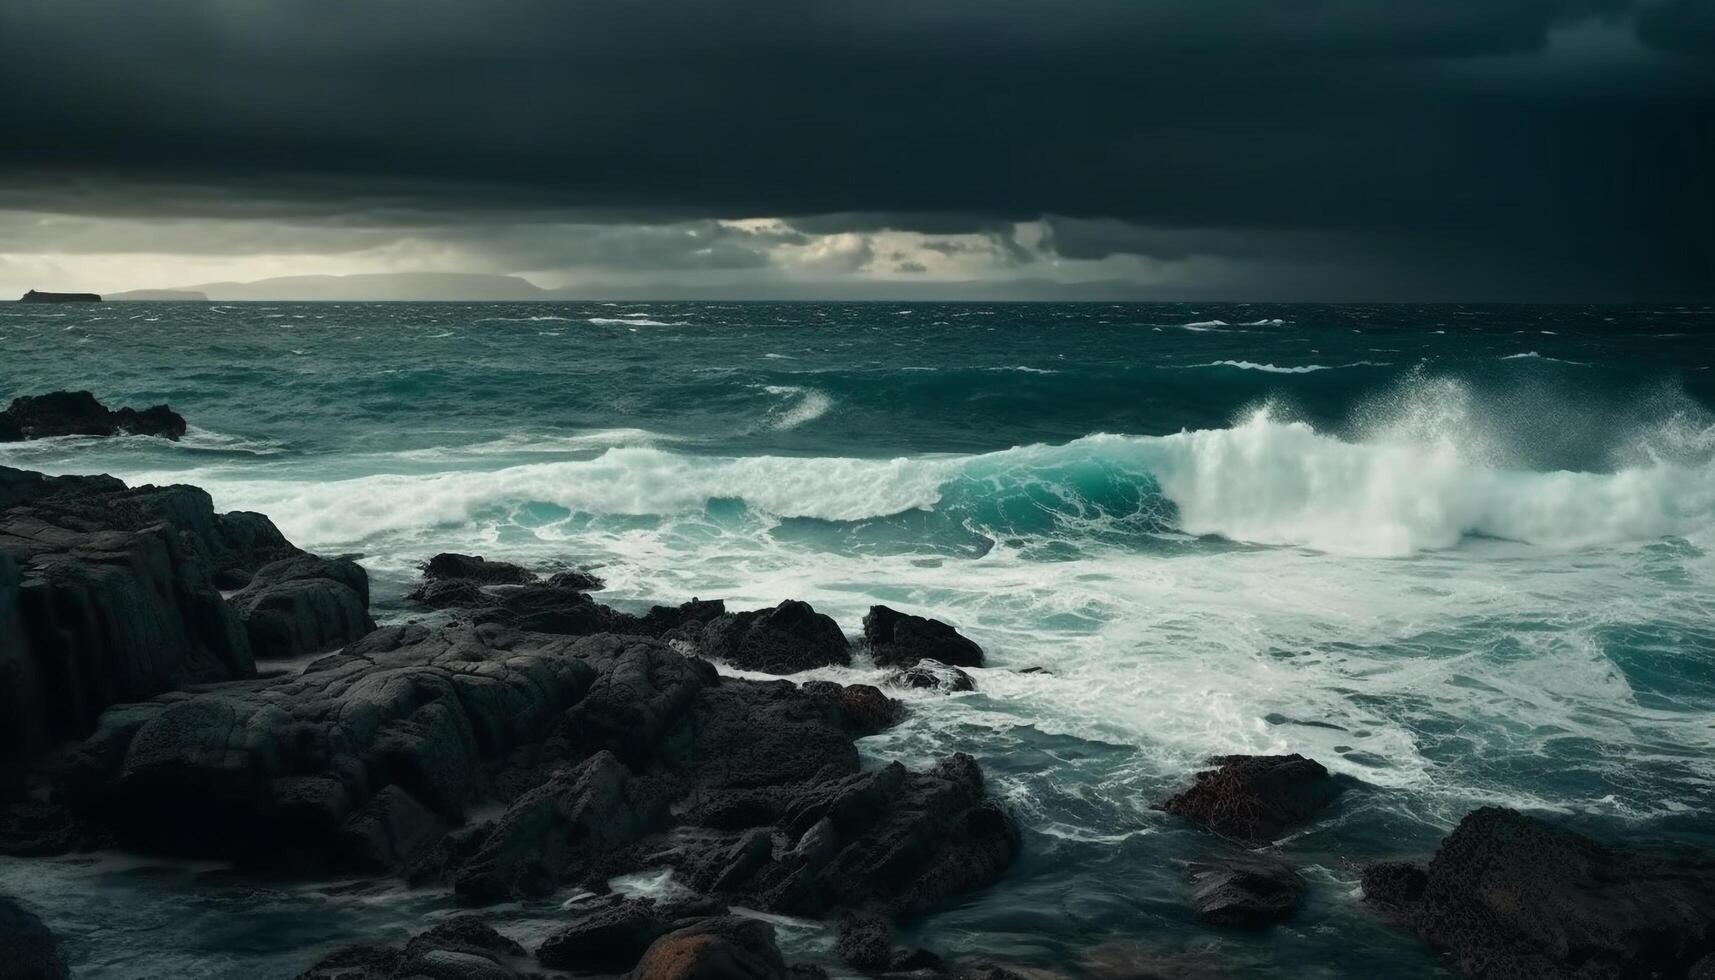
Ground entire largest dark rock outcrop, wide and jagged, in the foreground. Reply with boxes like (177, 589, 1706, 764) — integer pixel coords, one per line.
(36, 626, 1019, 915)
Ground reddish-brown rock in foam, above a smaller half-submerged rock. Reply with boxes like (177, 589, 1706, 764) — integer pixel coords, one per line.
(1156, 755, 1341, 843)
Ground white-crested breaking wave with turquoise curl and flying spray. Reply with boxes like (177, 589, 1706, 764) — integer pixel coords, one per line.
(163, 403, 1715, 556)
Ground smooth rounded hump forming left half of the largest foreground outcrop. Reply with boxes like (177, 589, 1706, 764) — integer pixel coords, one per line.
(65, 626, 595, 862)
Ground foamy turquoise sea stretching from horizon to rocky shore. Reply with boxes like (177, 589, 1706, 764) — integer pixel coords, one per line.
(0, 304, 1715, 978)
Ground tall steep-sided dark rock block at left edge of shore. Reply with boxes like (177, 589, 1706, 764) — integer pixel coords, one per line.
(0, 467, 295, 786)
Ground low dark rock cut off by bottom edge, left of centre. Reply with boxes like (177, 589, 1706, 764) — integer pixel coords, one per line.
(297, 915, 528, 980)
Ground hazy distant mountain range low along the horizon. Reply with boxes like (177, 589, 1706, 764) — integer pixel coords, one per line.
(105, 273, 1151, 302)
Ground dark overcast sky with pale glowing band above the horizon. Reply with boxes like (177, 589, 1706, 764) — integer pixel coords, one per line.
(0, 0, 1715, 300)
